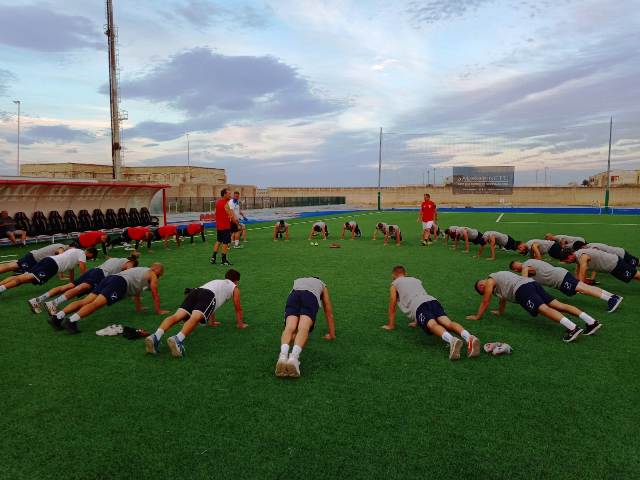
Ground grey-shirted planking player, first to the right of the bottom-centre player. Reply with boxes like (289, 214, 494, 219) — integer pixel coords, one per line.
(382, 265, 480, 360)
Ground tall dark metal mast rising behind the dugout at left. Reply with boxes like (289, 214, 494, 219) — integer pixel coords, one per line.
(104, 0, 122, 179)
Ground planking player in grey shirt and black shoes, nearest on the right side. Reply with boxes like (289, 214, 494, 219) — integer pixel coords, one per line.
(467, 272, 602, 343)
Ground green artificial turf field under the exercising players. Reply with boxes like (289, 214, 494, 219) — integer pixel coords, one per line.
(0, 212, 640, 480)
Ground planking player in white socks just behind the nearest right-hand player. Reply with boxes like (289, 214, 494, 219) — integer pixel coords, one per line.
(509, 259, 622, 312)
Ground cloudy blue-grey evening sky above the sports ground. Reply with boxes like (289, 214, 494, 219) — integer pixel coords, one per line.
(0, 0, 640, 187)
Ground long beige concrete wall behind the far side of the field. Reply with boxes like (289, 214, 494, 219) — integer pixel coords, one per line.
(268, 185, 640, 207)
